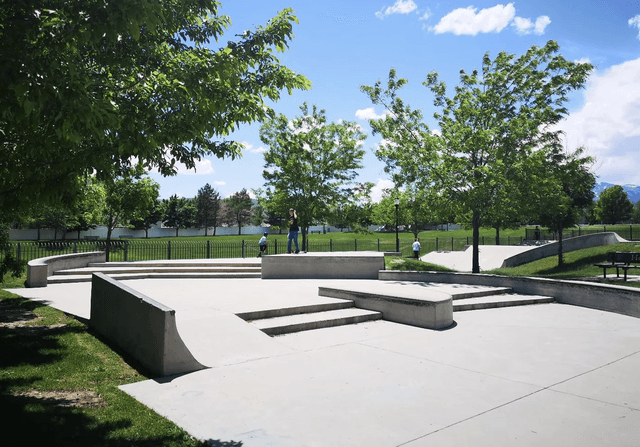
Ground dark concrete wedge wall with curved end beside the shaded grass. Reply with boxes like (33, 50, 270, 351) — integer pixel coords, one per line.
(89, 273, 205, 376)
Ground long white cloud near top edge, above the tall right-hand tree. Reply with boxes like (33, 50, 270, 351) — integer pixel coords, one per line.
(430, 3, 516, 36)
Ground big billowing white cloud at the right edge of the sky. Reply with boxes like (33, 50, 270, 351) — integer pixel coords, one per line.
(560, 58, 640, 184)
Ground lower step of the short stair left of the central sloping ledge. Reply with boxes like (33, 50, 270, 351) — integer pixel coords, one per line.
(251, 307, 382, 336)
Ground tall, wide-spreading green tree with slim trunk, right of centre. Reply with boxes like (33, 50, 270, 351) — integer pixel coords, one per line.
(362, 41, 593, 273)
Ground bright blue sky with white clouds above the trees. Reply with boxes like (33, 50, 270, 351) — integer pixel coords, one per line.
(150, 0, 640, 201)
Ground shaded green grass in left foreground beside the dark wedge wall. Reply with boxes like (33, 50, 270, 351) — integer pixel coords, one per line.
(0, 286, 204, 447)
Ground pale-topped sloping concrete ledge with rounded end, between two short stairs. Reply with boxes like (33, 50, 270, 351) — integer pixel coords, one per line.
(318, 283, 453, 329)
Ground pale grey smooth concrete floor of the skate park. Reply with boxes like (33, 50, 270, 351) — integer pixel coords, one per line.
(5, 250, 640, 447)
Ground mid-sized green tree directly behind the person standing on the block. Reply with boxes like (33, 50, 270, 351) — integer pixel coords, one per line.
(256, 103, 366, 250)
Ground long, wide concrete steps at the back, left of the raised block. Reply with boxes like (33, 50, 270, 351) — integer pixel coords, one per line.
(47, 260, 261, 284)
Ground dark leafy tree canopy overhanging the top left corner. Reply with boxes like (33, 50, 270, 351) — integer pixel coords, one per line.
(0, 0, 309, 216)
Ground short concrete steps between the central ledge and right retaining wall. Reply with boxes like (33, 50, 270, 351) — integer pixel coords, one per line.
(453, 287, 555, 312)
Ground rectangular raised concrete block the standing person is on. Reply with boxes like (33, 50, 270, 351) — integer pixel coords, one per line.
(262, 251, 384, 279)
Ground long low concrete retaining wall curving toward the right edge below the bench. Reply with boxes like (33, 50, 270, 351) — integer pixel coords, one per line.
(380, 270, 640, 318)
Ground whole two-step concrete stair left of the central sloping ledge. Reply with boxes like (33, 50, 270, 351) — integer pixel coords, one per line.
(237, 300, 382, 336)
